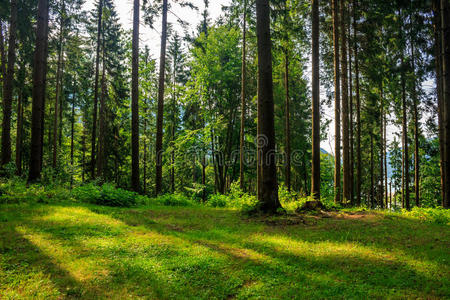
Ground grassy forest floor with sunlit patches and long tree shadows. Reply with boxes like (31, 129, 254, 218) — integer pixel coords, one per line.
(0, 204, 450, 299)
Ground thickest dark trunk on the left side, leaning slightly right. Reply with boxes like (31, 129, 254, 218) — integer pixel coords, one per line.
(28, 0, 49, 182)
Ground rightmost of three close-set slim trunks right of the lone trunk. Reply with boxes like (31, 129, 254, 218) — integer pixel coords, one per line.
(353, 0, 362, 205)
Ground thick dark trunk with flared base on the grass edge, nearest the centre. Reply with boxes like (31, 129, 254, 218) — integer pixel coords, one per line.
(256, 0, 281, 213)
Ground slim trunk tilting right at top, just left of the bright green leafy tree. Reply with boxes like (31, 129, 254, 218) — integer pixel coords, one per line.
(155, 0, 167, 195)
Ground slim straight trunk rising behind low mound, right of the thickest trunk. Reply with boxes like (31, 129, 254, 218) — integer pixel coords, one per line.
(311, 0, 320, 200)
